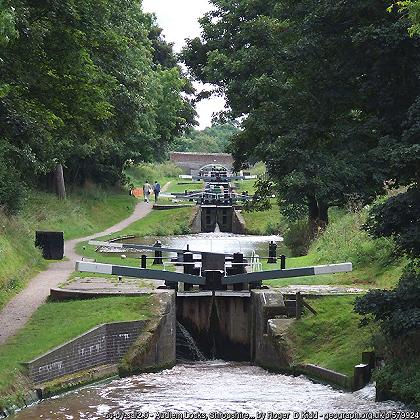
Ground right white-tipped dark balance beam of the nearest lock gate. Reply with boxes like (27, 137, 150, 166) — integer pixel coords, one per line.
(222, 262, 353, 284)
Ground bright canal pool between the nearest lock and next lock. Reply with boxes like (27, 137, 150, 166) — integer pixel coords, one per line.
(123, 232, 283, 257)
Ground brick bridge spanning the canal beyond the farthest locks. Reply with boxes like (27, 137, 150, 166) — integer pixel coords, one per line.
(170, 152, 233, 175)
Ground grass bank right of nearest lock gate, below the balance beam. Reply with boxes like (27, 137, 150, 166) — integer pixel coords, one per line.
(290, 296, 373, 375)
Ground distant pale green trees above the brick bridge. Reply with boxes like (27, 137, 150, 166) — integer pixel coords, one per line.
(171, 123, 239, 153)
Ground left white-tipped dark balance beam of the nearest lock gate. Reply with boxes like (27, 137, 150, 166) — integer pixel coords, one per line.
(76, 261, 206, 285)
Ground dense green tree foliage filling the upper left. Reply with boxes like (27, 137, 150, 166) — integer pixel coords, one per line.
(0, 0, 195, 213)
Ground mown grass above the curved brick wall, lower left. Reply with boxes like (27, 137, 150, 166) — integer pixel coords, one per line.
(0, 296, 153, 406)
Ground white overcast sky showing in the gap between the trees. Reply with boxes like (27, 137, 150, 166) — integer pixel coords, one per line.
(143, 0, 225, 129)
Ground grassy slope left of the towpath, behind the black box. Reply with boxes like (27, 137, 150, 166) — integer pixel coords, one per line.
(0, 187, 136, 309)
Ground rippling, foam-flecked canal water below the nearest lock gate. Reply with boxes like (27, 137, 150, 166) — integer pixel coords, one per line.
(13, 360, 404, 420)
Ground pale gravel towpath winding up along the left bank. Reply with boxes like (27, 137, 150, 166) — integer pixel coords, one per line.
(0, 203, 152, 344)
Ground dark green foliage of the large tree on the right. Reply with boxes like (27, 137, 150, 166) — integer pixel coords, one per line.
(183, 0, 420, 233)
